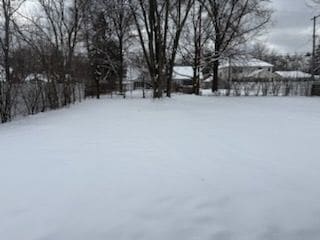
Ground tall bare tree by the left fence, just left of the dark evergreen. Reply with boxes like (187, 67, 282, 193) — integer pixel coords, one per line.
(36, 0, 88, 105)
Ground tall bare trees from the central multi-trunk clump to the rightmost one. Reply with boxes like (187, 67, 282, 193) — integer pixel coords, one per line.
(129, 0, 272, 97)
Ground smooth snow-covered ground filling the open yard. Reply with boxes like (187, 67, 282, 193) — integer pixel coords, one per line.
(0, 96, 320, 240)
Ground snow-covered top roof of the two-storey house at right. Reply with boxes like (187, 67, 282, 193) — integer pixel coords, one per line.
(219, 57, 273, 68)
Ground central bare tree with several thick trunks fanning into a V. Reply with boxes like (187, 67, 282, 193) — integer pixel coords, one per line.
(130, 0, 193, 98)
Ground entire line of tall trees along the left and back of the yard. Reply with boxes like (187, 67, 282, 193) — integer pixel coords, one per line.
(0, 0, 272, 122)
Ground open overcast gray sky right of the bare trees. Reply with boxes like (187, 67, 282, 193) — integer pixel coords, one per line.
(263, 0, 320, 53)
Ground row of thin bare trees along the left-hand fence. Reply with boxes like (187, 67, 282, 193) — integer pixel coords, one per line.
(0, 0, 87, 122)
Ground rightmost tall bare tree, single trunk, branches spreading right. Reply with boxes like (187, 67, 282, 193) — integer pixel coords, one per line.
(200, 0, 272, 92)
